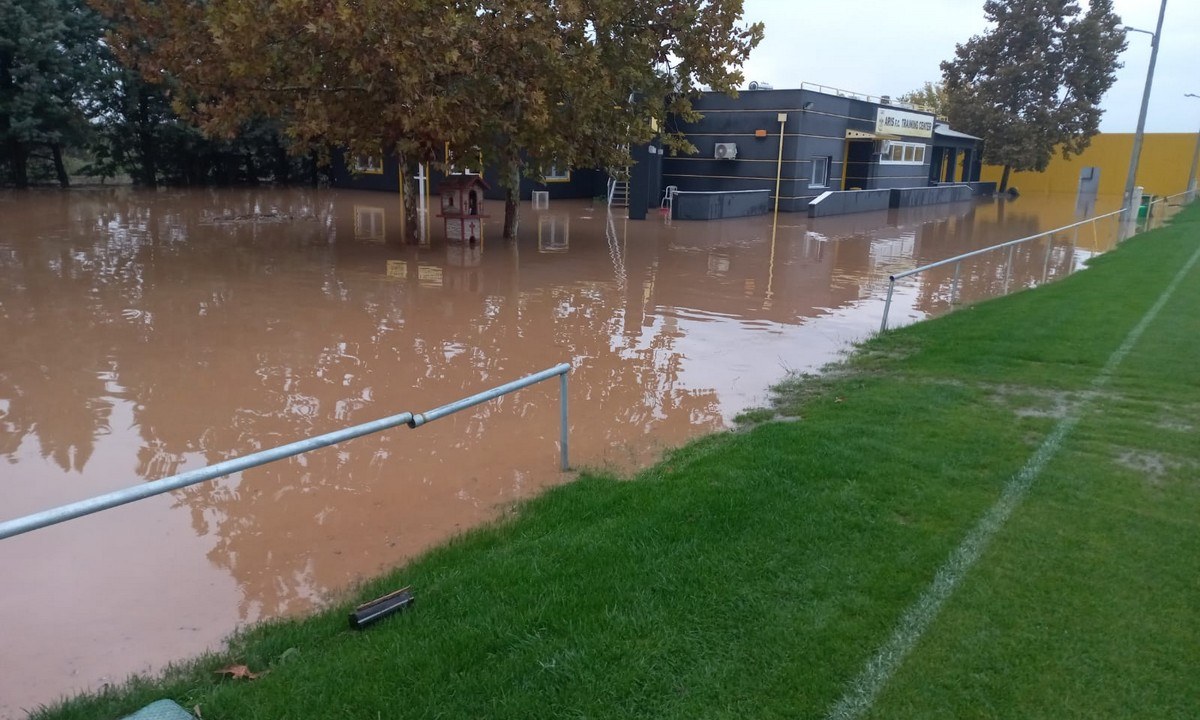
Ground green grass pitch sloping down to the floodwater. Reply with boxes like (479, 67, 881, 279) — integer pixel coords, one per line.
(44, 208, 1200, 720)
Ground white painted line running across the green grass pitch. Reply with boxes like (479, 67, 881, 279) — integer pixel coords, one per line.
(827, 238, 1200, 720)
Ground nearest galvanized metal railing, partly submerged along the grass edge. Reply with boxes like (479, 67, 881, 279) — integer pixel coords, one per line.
(0, 362, 571, 540)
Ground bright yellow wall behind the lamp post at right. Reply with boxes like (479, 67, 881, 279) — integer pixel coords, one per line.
(982, 133, 1196, 196)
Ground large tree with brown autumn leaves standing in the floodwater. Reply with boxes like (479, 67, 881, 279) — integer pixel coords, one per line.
(94, 0, 762, 236)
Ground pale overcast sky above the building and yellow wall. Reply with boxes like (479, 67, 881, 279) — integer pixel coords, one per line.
(744, 0, 1200, 132)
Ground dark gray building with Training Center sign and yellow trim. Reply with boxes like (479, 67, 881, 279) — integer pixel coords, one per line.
(331, 86, 986, 220)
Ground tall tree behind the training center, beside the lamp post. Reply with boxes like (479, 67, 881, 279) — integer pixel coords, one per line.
(942, 0, 1126, 191)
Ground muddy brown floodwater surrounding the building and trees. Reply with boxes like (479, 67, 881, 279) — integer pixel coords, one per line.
(0, 188, 1116, 716)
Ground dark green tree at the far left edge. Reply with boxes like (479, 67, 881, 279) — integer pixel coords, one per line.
(0, 0, 103, 187)
